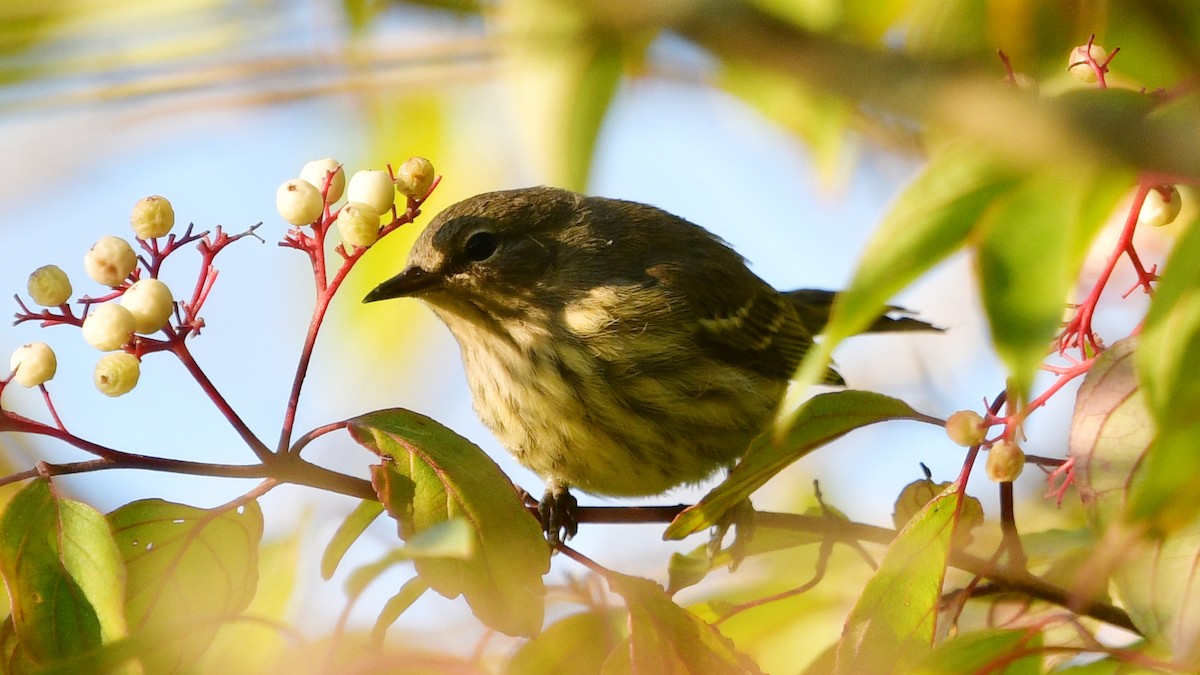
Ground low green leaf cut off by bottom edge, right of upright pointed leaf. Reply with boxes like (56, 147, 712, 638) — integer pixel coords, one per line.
(912, 629, 1044, 675)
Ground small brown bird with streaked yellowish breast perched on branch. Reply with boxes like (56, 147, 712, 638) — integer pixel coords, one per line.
(364, 187, 934, 542)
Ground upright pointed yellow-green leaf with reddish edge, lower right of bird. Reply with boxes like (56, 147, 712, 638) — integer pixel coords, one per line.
(838, 485, 959, 674)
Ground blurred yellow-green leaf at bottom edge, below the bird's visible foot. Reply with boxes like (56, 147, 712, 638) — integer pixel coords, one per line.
(504, 611, 622, 675)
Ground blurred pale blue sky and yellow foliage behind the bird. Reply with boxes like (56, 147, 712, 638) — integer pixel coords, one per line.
(0, 0, 1195, 669)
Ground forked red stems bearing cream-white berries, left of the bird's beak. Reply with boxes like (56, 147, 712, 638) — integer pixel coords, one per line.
(0, 157, 437, 429)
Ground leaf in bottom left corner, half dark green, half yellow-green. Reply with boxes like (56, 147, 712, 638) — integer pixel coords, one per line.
(0, 479, 126, 664)
